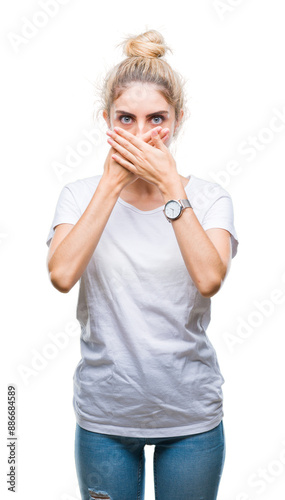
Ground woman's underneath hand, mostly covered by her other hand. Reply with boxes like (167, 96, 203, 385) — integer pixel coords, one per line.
(103, 127, 169, 189)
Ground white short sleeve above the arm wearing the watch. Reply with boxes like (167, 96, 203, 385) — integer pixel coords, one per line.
(202, 194, 239, 258)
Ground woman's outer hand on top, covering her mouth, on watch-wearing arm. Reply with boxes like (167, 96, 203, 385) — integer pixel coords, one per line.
(106, 127, 179, 187)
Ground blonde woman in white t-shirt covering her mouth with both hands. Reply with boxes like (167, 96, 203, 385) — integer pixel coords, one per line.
(47, 30, 238, 500)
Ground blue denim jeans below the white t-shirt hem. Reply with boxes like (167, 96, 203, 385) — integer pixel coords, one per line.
(75, 421, 225, 500)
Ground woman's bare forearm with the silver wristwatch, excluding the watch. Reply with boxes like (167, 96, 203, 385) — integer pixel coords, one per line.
(159, 176, 226, 297)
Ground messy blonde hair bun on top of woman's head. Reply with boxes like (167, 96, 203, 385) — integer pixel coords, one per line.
(119, 30, 172, 57)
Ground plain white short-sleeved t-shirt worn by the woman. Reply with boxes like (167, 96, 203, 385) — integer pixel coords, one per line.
(47, 175, 238, 437)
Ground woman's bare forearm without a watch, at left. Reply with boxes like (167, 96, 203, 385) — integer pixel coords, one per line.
(48, 175, 121, 292)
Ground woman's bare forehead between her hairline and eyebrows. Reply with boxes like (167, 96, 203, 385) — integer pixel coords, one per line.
(113, 82, 171, 114)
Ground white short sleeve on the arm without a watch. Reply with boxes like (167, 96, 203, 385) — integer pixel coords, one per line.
(46, 185, 81, 246)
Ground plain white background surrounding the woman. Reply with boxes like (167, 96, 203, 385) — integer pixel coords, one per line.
(0, 0, 285, 500)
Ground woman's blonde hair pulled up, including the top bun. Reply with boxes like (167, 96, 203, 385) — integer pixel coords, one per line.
(94, 30, 188, 139)
